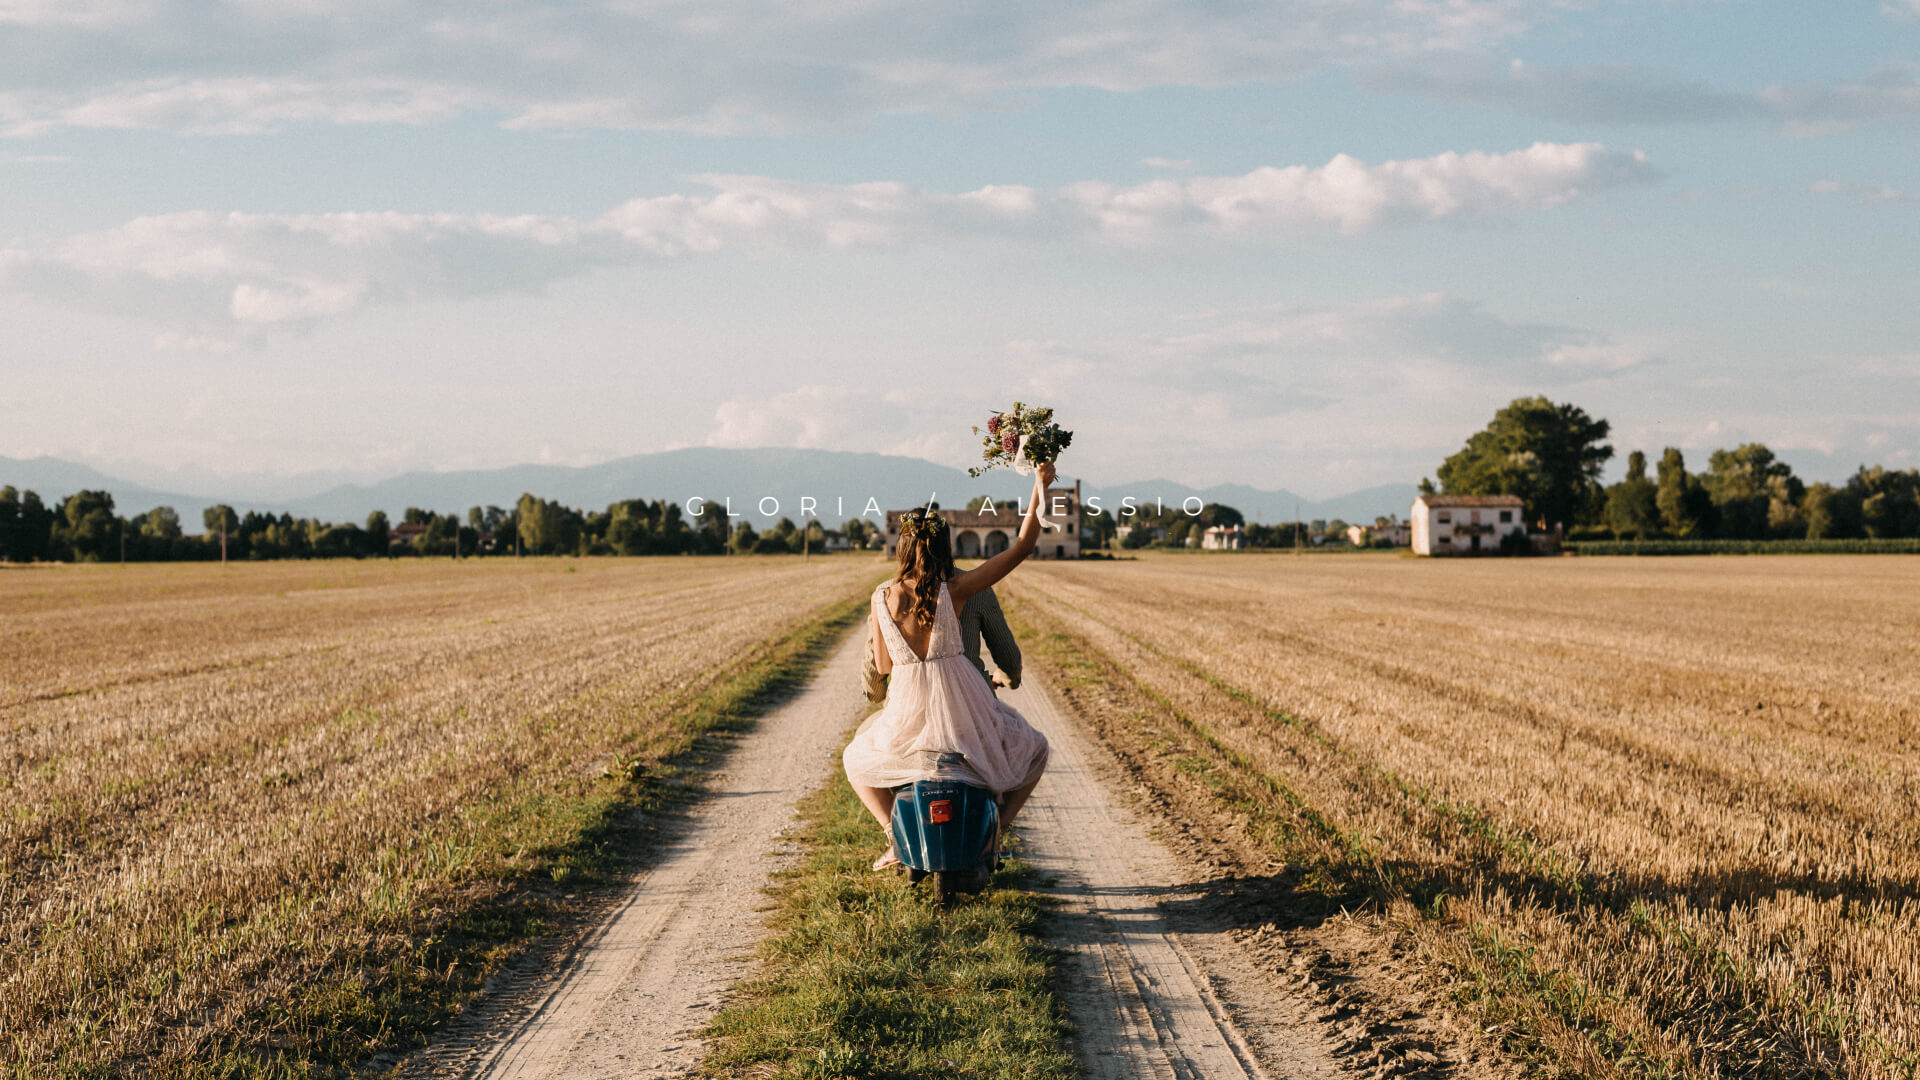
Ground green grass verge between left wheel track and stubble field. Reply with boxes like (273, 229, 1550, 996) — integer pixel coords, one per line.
(147, 598, 866, 1080)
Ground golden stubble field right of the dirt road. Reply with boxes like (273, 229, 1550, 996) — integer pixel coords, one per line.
(1002, 555, 1920, 1078)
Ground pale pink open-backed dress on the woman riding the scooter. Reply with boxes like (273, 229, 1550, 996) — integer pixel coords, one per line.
(841, 582, 1046, 796)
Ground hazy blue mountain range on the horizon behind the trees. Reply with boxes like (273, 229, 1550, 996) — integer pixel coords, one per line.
(0, 446, 1415, 532)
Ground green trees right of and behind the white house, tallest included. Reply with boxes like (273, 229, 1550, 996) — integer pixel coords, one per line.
(1421, 398, 1920, 540)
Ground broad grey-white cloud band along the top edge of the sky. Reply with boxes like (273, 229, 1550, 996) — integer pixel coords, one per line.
(0, 0, 1534, 133)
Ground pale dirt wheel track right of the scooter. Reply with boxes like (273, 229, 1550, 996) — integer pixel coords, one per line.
(1002, 682, 1340, 1080)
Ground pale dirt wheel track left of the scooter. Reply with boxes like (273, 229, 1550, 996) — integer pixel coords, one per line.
(405, 634, 866, 1080)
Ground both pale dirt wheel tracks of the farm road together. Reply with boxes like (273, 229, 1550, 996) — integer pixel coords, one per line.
(405, 634, 1338, 1080)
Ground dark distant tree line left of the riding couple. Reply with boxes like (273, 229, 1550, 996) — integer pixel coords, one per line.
(0, 486, 879, 563)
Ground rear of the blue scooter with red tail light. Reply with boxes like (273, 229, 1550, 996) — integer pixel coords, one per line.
(893, 755, 1000, 907)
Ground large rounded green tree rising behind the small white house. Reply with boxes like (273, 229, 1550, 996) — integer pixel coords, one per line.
(1440, 398, 1613, 527)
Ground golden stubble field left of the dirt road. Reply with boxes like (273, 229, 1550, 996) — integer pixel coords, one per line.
(0, 557, 883, 1076)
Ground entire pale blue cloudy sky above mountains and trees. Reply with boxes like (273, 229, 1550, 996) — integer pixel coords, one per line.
(0, 0, 1920, 498)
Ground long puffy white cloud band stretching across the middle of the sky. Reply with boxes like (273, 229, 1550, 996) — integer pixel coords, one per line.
(0, 142, 1657, 342)
